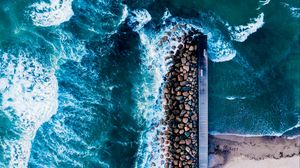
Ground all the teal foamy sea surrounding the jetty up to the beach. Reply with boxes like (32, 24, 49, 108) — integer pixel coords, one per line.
(0, 0, 300, 168)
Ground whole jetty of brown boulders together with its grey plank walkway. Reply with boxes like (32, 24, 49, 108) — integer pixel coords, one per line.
(151, 25, 207, 168)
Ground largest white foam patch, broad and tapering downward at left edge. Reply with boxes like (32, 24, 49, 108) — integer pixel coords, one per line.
(0, 53, 58, 167)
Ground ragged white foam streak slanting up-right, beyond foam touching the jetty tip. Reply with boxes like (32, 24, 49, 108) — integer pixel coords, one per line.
(225, 13, 264, 42)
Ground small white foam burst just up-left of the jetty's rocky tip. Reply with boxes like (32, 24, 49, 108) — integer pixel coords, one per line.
(128, 9, 152, 31)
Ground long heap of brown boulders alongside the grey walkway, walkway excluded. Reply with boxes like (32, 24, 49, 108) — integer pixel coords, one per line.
(153, 25, 204, 168)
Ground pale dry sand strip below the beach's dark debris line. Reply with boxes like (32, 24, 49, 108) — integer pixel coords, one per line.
(224, 156, 300, 168)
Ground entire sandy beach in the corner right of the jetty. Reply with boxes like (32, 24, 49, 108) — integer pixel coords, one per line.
(209, 135, 300, 168)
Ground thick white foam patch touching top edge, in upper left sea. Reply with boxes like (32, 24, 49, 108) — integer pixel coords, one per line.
(30, 0, 74, 27)
